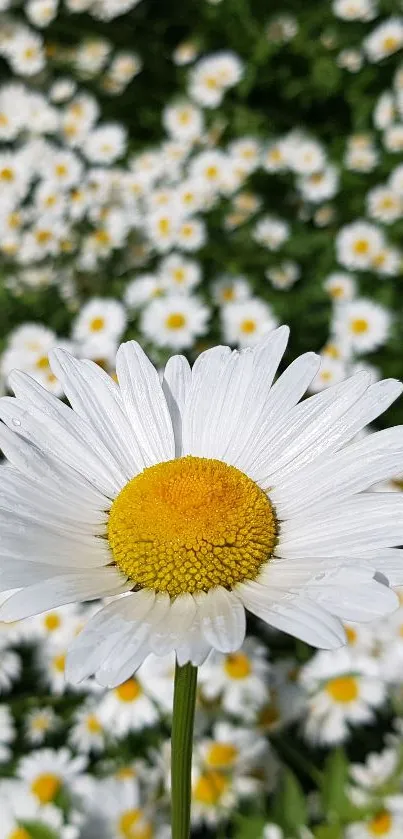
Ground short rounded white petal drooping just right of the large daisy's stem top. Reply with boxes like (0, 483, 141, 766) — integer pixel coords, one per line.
(199, 586, 246, 653)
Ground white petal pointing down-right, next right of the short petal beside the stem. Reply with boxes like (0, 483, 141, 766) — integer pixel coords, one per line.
(237, 582, 346, 650)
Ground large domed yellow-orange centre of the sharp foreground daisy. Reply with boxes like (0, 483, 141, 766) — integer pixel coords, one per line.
(108, 456, 277, 597)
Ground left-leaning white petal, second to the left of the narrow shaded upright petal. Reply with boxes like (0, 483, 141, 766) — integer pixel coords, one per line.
(49, 350, 145, 480)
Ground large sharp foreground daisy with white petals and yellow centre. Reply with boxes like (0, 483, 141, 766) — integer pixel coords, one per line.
(0, 324, 403, 687)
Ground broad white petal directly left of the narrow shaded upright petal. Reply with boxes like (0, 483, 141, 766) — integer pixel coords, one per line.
(116, 341, 175, 466)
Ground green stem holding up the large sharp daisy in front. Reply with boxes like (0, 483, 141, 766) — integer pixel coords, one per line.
(171, 663, 197, 839)
